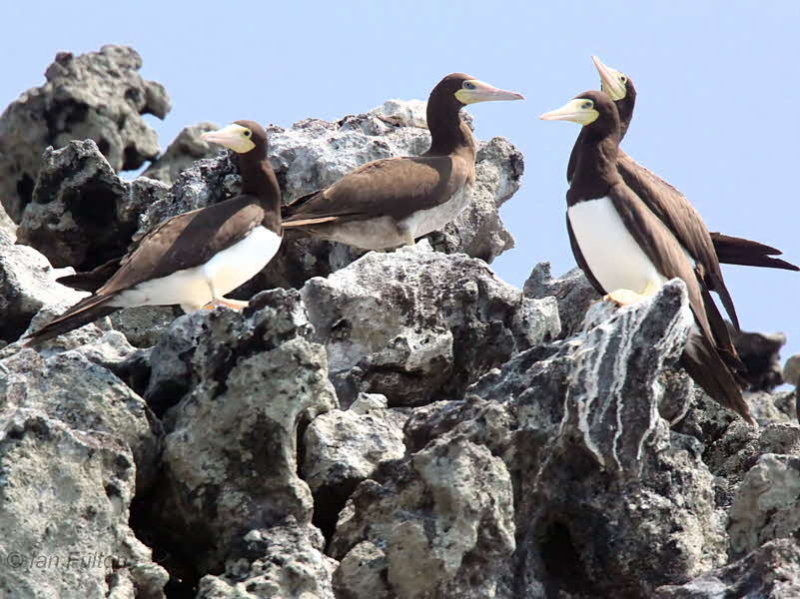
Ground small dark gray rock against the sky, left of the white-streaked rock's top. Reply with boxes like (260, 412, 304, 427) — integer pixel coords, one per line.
(523, 262, 600, 337)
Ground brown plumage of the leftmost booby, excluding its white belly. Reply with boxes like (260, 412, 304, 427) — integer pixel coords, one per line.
(26, 121, 282, 344)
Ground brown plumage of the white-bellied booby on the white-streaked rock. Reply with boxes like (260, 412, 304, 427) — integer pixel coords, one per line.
(552, 91, 753, 423)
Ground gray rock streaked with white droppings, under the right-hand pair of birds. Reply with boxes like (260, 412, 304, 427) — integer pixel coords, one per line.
(404, 281, 725, 597)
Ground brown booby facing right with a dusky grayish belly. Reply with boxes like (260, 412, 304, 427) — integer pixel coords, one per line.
(283, 73, 523, 250)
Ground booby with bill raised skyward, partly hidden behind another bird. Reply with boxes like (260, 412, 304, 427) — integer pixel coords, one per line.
(567, 56, 800, 318)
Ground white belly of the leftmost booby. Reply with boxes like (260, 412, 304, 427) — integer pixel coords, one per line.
(110, 226, 282, 311)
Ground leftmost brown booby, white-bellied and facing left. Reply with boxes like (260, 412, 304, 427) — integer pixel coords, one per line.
(27, 121, 283, 344)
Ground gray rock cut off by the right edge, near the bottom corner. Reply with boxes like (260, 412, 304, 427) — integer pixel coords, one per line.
(728, 453, 800, 556)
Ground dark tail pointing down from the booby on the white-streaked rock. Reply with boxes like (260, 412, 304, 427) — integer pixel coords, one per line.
(681, 330, 755, 424)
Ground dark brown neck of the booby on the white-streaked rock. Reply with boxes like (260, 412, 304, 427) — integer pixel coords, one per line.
(568, 129, 621, 204)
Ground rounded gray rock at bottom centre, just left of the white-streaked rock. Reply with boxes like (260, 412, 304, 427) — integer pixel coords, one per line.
(330, 440, 514, 598)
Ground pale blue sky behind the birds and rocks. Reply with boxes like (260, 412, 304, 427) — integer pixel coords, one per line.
(0, 0, 800, 358)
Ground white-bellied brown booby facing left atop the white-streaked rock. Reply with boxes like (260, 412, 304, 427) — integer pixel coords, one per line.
(540, 91, 753, 423)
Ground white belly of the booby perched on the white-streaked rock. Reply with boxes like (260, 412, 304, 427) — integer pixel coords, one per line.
(567, 198, 667, 293)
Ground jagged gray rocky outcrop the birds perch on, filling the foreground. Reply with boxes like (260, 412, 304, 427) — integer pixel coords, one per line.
(0, 44, 800, 599)
